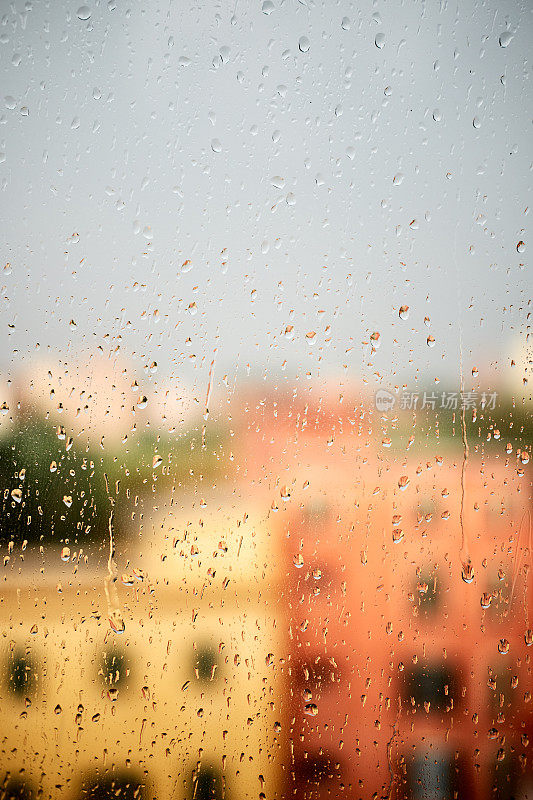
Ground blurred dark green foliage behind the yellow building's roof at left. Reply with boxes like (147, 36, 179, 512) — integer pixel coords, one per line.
(0, 413, 222, 547)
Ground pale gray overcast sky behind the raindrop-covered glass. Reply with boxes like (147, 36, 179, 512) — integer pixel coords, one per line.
(0, 0, 532, 400)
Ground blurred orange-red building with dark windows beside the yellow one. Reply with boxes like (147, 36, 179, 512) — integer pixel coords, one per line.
(235, 390, 533, 800)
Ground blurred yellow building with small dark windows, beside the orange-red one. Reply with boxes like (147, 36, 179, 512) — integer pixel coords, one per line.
(0, 494, 283, 800)
